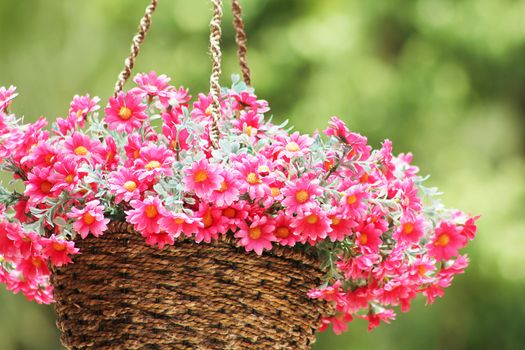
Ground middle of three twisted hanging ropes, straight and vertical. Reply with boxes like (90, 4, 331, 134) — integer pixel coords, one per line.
(210, 0, 222, 148)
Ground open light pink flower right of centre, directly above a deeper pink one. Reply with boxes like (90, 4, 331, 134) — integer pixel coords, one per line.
(281, 176, 323, 215)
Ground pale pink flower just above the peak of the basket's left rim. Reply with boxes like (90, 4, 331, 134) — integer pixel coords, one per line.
(108, 167, 147, 204)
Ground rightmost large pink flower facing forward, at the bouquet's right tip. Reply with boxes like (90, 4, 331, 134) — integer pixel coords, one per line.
(427, 221, 467, 260)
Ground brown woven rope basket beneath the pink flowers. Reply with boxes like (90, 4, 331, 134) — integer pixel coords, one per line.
(52, 222, 328, 349)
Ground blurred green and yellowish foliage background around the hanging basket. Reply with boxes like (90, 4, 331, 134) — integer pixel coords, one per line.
(0, 0, 525, 350)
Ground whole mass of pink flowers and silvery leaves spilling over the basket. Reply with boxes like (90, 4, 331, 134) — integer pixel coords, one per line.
(0, 72, 477, 333)
